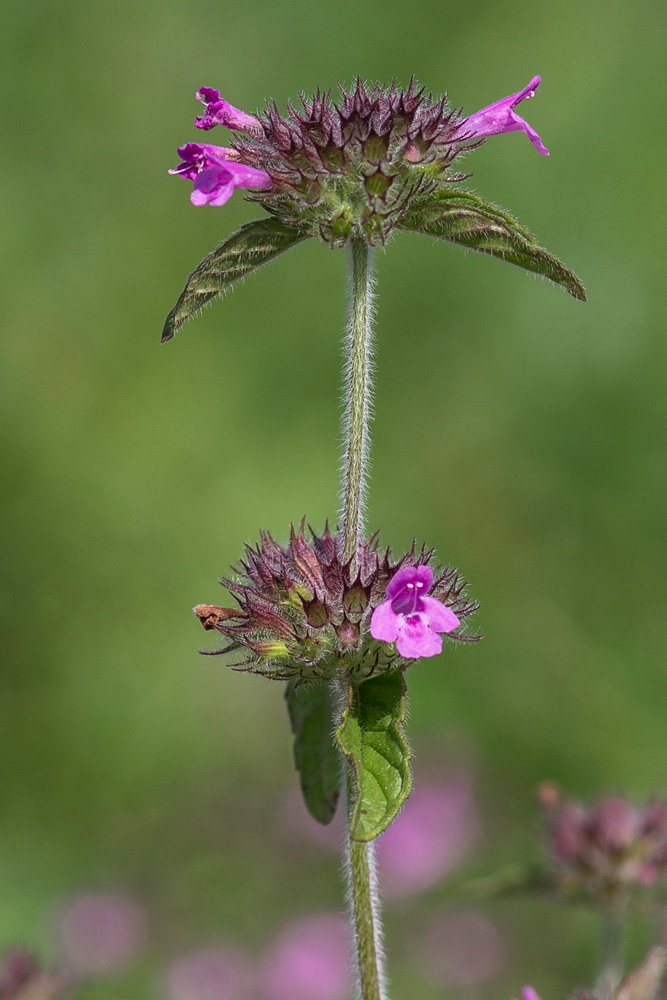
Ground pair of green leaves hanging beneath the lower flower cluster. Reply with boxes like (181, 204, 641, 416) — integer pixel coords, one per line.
(285, 670, 412, 842)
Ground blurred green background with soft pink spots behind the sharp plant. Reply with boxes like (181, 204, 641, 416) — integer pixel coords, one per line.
(0, 0, 667, 1000)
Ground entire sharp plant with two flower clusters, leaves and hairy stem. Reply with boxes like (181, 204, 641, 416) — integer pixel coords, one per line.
(162, 77, 585, 1000)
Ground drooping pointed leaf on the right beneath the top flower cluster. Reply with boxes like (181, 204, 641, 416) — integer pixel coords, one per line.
(399, 191, 586, 302)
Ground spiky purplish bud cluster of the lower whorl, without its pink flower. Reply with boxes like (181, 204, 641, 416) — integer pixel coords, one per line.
(194, 522, 477, 680)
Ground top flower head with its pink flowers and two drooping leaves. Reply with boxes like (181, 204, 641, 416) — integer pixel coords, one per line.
(162, 76, 585, 341)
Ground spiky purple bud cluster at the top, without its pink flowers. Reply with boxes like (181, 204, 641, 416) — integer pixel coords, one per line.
(232, 79, 478, 246)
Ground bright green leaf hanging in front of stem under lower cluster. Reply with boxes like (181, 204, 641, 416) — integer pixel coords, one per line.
(336, 670, 412, 842)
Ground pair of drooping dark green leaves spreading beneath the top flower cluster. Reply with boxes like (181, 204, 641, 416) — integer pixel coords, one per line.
(162, 189, 586, 343)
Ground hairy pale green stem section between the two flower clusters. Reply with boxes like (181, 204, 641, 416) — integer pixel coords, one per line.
(342, 239, 373, 559)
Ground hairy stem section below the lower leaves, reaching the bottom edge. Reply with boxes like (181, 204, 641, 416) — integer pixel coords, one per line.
(345, 768, 387, 1000)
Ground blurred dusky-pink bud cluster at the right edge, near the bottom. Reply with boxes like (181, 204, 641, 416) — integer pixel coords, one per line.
(539, 783, 667, 906)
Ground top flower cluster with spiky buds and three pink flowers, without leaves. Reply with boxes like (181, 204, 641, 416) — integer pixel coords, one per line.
(172, 76, 548, 246)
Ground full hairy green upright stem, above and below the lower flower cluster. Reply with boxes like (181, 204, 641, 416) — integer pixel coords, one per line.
(341, 239, 386, 1000)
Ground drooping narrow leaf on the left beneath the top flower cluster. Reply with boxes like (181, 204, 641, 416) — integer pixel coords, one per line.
(162, 219, 306, 344)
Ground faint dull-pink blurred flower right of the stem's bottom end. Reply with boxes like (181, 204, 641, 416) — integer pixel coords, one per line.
(422, 910, 507, 989)
